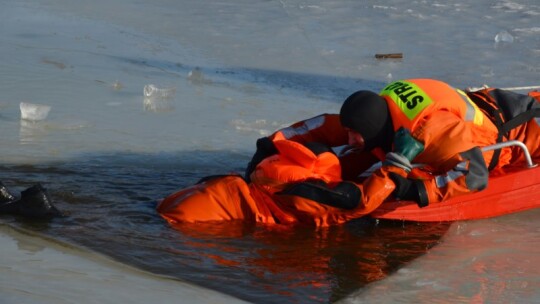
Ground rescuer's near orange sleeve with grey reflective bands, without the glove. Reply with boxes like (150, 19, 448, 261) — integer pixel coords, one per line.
(412, 111, 497, 206)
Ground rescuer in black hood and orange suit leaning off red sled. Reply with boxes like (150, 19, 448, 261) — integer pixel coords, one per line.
(245, 79, 540, 217)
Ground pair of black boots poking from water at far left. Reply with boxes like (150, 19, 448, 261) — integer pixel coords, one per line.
(0, 184, 62, 218)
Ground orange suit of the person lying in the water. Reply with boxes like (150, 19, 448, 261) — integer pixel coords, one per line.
(157, 134, 362, 226)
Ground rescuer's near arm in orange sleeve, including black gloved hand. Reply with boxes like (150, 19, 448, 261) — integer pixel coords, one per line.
(390, 113, 489, 207)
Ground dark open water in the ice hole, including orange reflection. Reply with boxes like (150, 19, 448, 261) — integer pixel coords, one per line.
(0, 159, 449, 303)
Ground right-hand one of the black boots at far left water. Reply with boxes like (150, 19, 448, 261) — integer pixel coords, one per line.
(15, 184, 62, 218)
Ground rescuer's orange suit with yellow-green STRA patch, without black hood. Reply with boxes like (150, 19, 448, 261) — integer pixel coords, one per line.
(264, 79, 540, 209)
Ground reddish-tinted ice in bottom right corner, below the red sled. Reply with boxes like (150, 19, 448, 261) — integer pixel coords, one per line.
(340, 209, 540, 304)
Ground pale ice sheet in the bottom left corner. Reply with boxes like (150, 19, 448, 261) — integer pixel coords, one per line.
(0, 225, 249, 304)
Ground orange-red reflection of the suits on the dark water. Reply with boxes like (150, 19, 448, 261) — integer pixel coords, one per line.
(175, 219, 448, 302)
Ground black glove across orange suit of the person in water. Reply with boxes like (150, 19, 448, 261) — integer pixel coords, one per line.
(277, 180, 362, 210)
